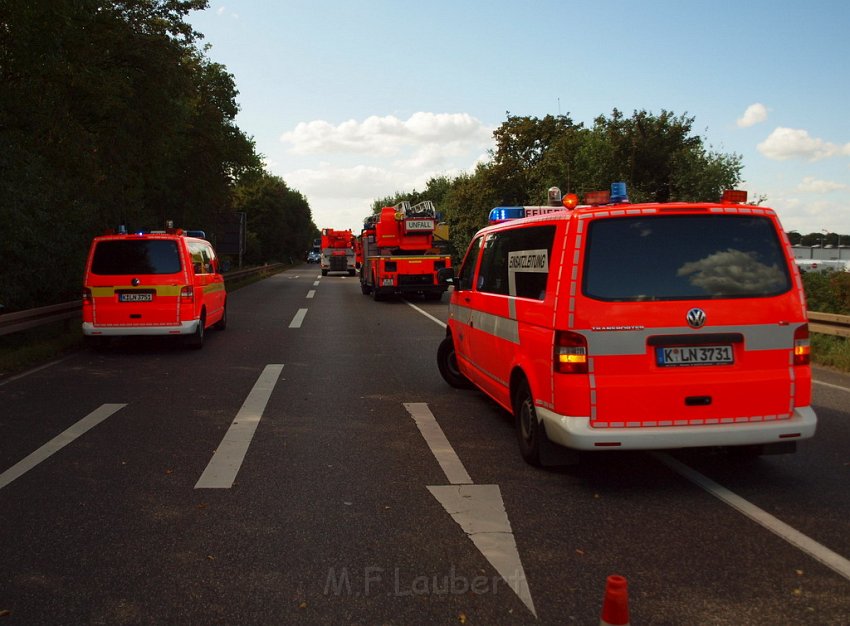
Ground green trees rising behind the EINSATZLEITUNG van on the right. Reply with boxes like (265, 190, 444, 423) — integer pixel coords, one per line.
(372, 109, 742, 254)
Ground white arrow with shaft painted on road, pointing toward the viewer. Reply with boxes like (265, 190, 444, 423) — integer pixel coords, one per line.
(404, 402, 537, 617)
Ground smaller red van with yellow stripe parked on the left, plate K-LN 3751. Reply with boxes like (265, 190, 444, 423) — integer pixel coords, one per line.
(83, 229, 227, 348)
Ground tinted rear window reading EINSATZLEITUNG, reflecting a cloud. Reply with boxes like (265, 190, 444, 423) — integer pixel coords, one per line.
(582, 215, 791, 302)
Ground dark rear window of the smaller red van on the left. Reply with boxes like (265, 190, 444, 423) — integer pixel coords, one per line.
(91, 239, 180, 276)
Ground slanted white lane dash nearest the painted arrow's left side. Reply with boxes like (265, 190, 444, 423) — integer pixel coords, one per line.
(195, 364, 283, 489)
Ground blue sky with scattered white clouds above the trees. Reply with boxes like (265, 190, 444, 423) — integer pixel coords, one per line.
(189, 0, 850, 236)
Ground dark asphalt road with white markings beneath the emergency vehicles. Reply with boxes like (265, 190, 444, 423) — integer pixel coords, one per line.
(0, 265, 850, 625)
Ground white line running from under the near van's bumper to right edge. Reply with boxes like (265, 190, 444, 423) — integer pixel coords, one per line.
(652, 452, 850, 580)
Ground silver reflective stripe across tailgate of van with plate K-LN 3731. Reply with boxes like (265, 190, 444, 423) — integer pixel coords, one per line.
(571, 322, 804, 356)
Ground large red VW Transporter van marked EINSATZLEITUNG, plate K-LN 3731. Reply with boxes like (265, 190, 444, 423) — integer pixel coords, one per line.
(438, 183, 816, 464)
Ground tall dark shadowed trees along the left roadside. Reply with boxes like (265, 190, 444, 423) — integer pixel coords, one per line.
(0, 0, 316, 311)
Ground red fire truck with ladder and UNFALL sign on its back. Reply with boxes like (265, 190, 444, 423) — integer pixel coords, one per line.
(360, 200, 451, 300)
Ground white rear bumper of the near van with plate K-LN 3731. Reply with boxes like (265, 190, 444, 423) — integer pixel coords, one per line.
(535, 406, 817, 450)
